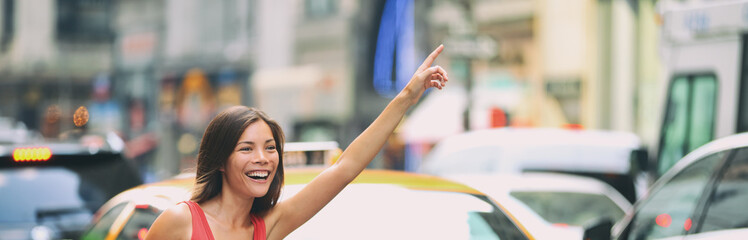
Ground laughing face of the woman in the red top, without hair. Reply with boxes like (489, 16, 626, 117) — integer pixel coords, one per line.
(221, 120, 279, 198)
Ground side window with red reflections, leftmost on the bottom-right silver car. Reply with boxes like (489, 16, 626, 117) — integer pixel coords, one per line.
(626, 152, 725, 240)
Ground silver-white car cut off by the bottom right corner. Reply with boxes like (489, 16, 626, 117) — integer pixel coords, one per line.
(585, 133, 748, 239)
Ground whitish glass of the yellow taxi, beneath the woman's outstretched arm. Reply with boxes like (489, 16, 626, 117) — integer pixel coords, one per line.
(283, 184, 526, 239)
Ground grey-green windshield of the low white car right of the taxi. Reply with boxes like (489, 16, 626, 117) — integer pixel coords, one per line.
(510, 191, 625, 226)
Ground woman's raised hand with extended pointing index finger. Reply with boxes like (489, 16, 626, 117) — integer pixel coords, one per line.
(400, 45, 449, 104)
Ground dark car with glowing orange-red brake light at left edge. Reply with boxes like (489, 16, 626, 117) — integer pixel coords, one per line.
(0, 130, 142, 240)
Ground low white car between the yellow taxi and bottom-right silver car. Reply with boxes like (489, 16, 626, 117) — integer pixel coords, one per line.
(447, 173, 631, 240)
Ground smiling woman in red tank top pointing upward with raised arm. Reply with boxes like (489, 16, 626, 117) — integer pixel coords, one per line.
(147, 45, 448, 240)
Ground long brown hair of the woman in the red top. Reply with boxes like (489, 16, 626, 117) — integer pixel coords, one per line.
(191, 106, 284, 213)
